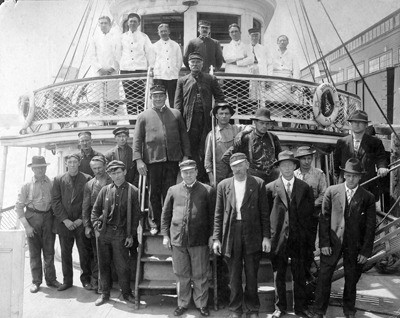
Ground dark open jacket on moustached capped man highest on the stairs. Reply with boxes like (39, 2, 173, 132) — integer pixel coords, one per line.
(174, 73, 225, 134)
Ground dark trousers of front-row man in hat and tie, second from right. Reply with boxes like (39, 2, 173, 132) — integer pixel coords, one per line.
(271, 251, 308, 312)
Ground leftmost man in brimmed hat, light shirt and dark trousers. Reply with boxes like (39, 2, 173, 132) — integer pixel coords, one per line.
(15, 156, 61, 293)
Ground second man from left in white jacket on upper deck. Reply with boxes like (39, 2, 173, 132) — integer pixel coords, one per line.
(120, 13, 153, 124)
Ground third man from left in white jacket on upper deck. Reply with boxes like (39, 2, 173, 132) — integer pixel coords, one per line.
(152, 23, 182, 107)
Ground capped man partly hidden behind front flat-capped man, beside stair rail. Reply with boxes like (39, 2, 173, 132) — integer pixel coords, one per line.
(104, 127, 139, 187)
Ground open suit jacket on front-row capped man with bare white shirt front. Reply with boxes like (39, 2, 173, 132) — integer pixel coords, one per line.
(213, 175, 271, 257)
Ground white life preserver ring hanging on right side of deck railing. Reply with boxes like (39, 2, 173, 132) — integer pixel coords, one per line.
(313, 83, 340, 127)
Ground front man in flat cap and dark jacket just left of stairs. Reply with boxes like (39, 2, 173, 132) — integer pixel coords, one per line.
(91, 160, 140, 306)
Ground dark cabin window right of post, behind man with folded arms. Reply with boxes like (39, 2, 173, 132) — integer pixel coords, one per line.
(197, 13, 238, 44)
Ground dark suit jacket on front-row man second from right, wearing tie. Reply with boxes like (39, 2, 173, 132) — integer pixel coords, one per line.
(266, 177, 316, 257)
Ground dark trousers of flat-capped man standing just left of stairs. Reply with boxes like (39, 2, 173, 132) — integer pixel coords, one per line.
(98, 227, 131, 296)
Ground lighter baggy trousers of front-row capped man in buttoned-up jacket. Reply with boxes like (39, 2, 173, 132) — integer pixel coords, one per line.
(172, 245, 210, 308)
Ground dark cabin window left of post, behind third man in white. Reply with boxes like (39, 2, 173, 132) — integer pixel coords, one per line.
(142, 13, 183, 47)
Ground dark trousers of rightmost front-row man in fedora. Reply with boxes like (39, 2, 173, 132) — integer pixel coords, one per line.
(314, 248, 363, 315)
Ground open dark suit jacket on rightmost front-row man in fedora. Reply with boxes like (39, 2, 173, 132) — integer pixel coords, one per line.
(319, 183, 376, 264)
